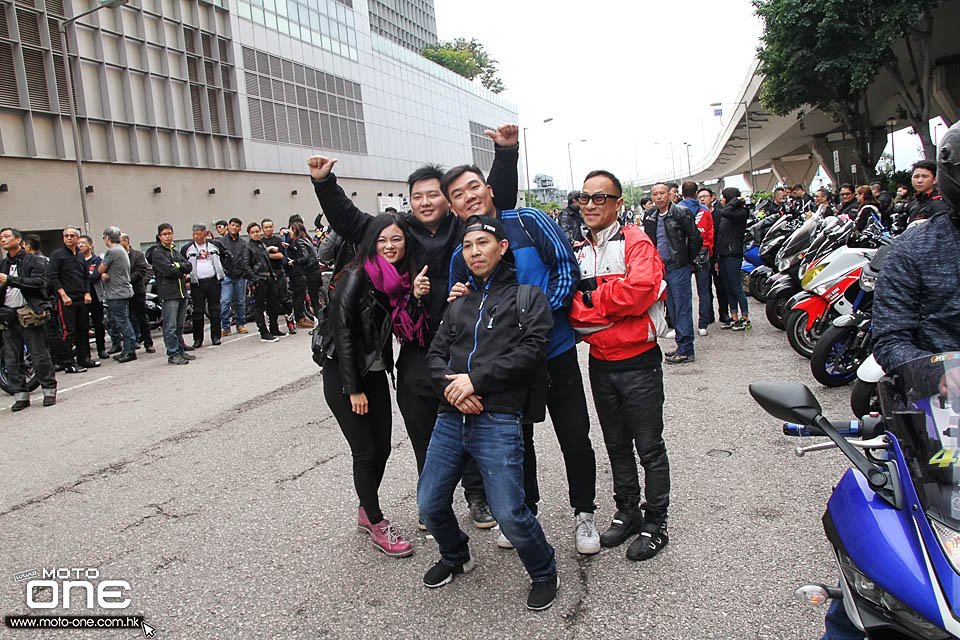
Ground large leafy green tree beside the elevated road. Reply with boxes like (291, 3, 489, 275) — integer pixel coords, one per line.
(753, 0, 940, 179)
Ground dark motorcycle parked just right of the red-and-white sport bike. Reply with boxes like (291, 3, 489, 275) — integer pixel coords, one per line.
(810, 247, 889, 384)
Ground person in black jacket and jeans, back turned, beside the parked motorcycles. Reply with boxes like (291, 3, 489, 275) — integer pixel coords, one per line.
(713, 187, 750, 331)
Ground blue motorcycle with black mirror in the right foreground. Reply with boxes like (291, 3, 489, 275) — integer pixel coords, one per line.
(750, 352, 960, 640)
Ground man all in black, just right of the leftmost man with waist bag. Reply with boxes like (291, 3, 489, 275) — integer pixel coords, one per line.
(47, 227, 99, 373)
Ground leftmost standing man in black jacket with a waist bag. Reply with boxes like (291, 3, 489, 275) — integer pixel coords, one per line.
(0, 228, 57, 411)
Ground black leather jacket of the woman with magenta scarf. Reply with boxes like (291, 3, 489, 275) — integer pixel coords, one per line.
(328, 265, 406, 395)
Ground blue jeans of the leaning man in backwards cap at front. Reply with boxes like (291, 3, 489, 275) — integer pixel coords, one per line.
(417, 411, 557, 582)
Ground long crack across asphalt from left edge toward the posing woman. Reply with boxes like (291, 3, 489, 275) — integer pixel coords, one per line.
(0, 374, 316, 518)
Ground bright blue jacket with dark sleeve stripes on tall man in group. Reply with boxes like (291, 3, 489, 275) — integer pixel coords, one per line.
(449, 208, 580, 359)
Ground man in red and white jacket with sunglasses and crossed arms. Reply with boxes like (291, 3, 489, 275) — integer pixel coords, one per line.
(570, 171, 670, 560)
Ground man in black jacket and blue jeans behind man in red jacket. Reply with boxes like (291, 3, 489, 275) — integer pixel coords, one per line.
(643, 182, 703, 364)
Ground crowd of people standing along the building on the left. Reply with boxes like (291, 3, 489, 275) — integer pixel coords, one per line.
(0, 214, 332, 411)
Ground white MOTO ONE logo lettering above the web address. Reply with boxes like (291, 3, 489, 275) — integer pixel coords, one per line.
(27, 567, 131, 609)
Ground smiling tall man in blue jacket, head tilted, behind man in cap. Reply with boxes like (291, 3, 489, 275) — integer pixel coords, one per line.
(440, 165, 600, 554)
